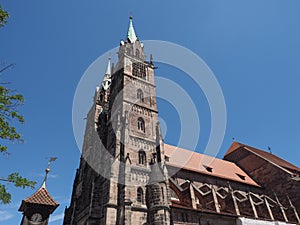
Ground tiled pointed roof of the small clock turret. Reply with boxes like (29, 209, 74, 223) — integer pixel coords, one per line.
(19, 187, 59, 211)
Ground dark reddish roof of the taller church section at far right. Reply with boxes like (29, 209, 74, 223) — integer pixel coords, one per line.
(224, 142, 300, 172)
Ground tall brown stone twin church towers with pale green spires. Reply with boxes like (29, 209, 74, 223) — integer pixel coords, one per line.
(63, 17, 171, 225)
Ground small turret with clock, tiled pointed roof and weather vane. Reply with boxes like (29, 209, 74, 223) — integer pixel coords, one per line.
(19, 160, 59, 225)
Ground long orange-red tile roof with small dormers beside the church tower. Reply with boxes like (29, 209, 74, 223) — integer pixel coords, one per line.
(164, 144, 259, 187)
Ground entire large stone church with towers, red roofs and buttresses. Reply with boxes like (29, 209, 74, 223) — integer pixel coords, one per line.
(62, 18, 300, 225)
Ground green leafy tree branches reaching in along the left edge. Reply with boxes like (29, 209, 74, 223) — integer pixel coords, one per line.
(0, 5, 36, 204)
